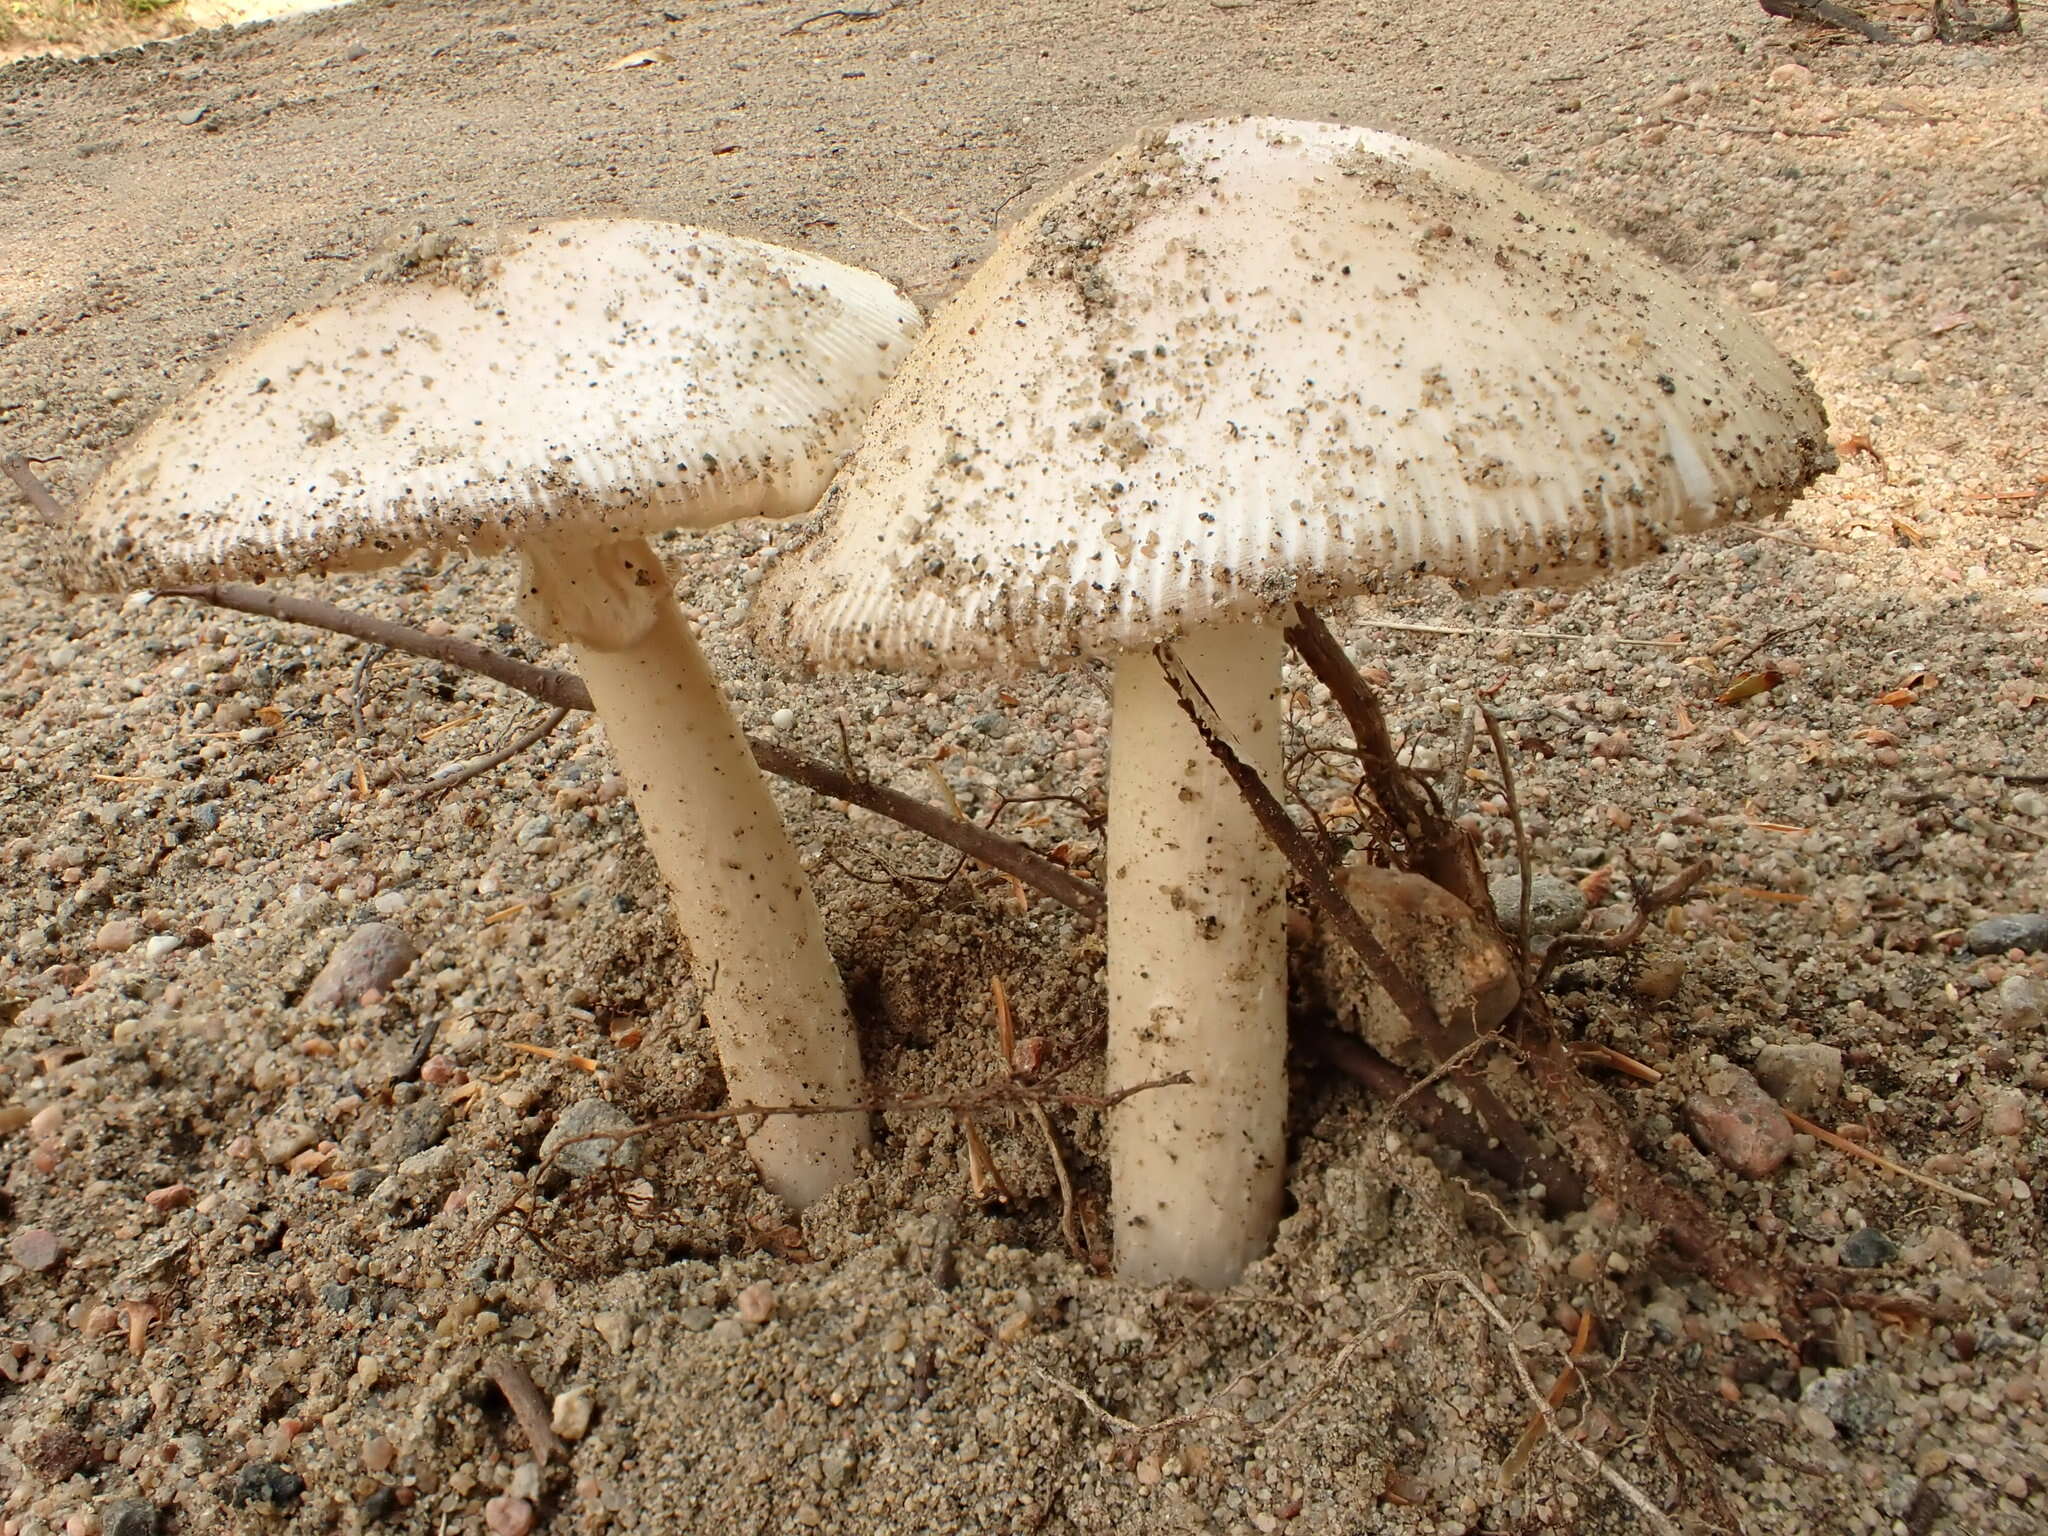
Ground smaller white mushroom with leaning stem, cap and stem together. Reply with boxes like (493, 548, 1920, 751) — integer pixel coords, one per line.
(74, 219, 920, 1206)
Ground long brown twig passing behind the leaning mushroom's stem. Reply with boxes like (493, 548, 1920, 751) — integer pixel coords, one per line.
(158, 586, 1106, 922)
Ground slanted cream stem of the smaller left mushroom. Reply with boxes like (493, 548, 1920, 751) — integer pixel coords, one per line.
(526, 539, 868, 1208)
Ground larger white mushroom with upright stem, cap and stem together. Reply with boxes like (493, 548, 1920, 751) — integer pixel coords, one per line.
(756, 119, 1831, 1286)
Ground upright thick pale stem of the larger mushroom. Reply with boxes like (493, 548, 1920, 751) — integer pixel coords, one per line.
(1108, 625, 1286, 1290)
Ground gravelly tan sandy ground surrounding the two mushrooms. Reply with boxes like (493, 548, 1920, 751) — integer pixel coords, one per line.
(0, 0, 2048, 1536)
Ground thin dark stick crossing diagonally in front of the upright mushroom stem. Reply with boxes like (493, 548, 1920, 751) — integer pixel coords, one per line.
(1153, 645, 1583, 1204)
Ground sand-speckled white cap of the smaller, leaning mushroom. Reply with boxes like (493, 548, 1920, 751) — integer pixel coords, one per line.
(64, 219, 920, 588)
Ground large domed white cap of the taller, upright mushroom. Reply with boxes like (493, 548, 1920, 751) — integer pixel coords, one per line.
(758, 119, 1833, 668)
